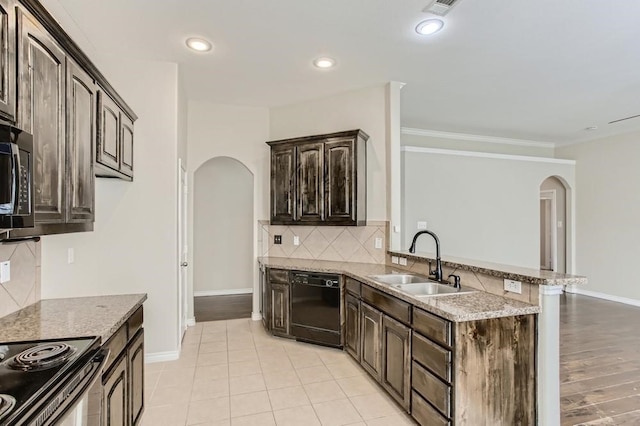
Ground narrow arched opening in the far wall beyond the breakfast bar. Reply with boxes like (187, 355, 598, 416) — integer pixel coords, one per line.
(540, 176, 571, 273)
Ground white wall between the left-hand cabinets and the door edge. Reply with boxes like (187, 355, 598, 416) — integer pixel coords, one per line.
(42, 57, 178, 354)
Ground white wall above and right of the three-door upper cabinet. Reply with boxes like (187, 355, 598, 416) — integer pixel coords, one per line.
(265, 85, 388, 221)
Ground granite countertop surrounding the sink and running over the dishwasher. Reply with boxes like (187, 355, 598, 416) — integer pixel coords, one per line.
(258, 257, 540, 322)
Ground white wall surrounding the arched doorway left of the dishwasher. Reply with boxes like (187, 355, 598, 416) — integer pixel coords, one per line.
(188, 101, 270, 317)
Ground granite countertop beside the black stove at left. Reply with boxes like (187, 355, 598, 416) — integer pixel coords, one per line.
(0, 294, 147, 343)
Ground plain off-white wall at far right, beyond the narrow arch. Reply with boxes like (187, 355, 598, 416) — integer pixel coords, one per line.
(557, 132, 640, 303)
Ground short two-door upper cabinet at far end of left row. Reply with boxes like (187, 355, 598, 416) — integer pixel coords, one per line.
(96, 90, 133, 180)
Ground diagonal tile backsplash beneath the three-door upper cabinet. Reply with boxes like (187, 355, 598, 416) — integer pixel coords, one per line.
(258, 221, 388, 263)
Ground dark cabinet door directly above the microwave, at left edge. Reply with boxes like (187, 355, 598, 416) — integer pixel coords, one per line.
(0, 0, 16, 121)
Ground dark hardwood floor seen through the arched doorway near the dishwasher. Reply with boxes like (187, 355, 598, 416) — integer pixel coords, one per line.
(193, 294, 253, 322)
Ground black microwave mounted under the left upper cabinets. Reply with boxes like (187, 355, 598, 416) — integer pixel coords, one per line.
(0, 124, 34, 229)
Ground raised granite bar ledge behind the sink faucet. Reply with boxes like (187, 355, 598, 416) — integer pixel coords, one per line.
(387, 250, 587, 285)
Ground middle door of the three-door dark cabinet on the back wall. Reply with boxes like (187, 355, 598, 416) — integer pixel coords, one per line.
(296, 142, 324, 222)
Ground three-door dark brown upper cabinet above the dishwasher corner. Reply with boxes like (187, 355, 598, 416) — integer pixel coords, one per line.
(267, 130, 369, 225)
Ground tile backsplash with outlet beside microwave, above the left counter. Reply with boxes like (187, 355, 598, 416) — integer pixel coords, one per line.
(0, 241, 40, 317)
